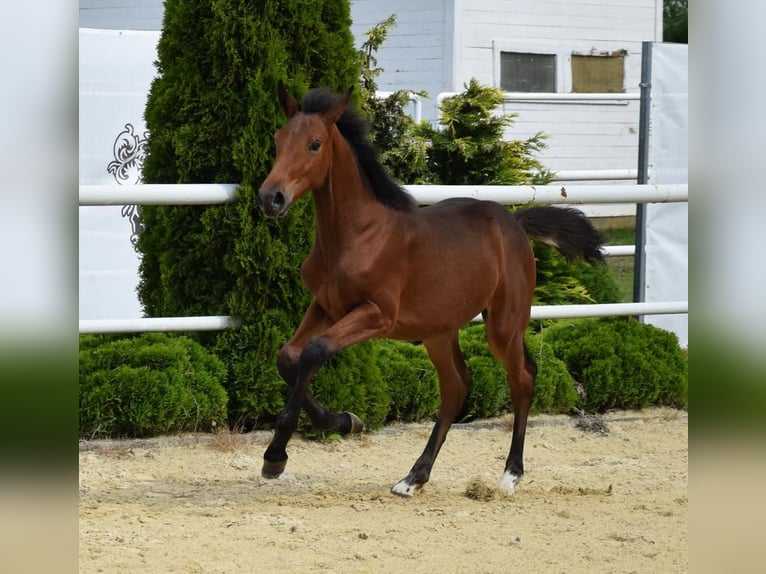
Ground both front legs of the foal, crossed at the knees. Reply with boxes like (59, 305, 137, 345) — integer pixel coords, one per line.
(261, 302, 387, 478)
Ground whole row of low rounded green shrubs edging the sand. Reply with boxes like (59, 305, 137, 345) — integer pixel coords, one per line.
(80, 318, 688, 438)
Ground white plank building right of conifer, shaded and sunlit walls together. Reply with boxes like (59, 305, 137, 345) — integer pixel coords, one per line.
(352, 0, 662, 176)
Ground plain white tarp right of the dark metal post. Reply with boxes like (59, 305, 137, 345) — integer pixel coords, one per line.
(644, 43, 689, 347)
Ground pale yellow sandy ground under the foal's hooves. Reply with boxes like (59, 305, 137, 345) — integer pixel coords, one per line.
(79, 409, 688, 574)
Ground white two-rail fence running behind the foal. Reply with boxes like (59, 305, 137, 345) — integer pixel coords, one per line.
(79, 184, 689, 334)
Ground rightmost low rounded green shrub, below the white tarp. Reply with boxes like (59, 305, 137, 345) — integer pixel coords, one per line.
(541, 317, 689, 412)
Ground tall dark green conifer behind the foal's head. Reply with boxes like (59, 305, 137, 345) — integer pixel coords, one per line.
(138, 0, 383, 428)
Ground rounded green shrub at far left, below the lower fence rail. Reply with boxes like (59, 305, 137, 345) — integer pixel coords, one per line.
(79, 334, 227, 438)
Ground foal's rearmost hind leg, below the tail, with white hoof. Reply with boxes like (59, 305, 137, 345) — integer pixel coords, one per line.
(487, 316, 537, 494)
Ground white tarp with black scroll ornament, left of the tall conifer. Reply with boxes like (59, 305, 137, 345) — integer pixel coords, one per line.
(79, 28, 160, 319)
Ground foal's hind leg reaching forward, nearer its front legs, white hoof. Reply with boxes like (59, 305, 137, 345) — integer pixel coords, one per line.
(391, 331, 471, 497)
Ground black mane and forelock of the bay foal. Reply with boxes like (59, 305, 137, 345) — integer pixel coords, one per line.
(301, 88, 416, 211)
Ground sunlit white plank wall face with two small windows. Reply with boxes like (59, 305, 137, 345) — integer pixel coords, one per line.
(454, 0, 662, 171)
